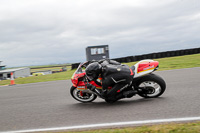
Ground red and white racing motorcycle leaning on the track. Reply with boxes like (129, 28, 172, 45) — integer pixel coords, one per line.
(70, 60, 166, 103)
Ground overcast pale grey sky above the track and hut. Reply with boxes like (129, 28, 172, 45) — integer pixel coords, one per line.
(0, 0, 200, 67)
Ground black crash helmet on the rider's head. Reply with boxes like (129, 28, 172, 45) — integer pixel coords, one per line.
(85, 62, 102, 80)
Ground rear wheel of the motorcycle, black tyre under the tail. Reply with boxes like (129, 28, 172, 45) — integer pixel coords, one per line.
(137, 74, 166, 98)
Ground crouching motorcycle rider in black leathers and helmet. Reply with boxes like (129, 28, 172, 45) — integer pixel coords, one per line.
(85, 59, 135, 102)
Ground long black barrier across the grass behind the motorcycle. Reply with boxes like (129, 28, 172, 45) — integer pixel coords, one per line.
(72, 48, 200, 69)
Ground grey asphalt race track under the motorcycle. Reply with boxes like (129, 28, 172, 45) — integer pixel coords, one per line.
(0, 67, 200, 132)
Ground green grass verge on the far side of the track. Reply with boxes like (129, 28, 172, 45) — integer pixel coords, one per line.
(0, 54, 200, 85)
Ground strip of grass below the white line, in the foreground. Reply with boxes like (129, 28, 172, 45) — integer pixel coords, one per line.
(41, 122, 200, 133)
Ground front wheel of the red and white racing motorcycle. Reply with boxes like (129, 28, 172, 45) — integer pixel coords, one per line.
(70, 86, 97, 103)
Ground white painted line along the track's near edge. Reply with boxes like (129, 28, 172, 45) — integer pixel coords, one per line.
(0, 117, 200, 133)
